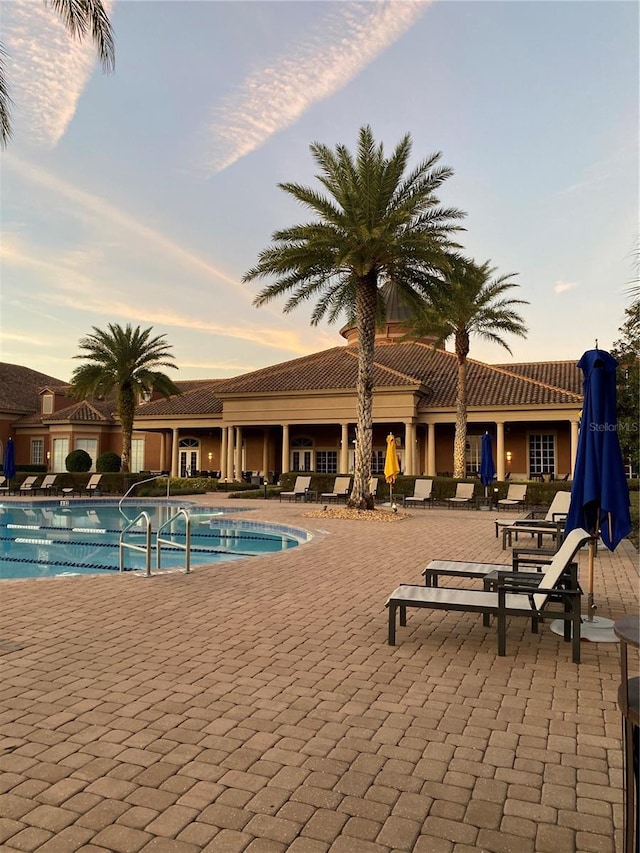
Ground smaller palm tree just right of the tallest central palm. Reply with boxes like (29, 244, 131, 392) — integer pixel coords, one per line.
(414, 255, 529, 478)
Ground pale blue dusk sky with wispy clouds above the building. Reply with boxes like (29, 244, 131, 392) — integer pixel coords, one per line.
(0, 0, 640, 380)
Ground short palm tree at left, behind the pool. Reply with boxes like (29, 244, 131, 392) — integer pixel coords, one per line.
(71, 323, 180, 474)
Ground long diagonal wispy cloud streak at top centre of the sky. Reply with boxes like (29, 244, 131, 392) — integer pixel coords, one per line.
(205, 0, 431, 175)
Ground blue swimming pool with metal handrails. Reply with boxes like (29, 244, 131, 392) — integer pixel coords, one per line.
(0, 498, 311, 580)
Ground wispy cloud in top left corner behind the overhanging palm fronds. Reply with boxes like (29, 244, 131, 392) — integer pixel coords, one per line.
(2, 0, 112, 148)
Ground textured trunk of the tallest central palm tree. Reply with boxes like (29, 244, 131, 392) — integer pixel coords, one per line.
(348, 273, 378, 509)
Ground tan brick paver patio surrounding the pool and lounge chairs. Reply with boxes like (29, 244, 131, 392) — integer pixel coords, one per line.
(0, 496, 638, 853)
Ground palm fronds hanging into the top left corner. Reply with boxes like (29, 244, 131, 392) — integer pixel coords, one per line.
(0, 0, 115, 148)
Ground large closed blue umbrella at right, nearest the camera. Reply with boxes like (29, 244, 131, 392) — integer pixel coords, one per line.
(565, 349, 631, 619)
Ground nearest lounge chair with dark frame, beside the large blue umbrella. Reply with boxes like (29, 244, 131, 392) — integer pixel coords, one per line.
(386, 529, 591, 663)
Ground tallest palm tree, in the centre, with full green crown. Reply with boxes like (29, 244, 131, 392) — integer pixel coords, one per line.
(244, 126, 464, 508)
